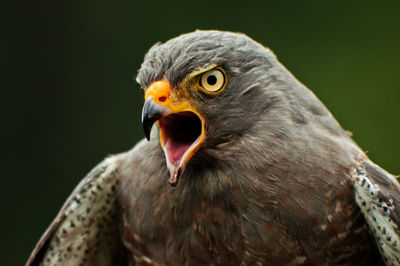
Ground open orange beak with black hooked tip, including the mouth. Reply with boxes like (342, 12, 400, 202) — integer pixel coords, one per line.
(142, 80, 205, 186)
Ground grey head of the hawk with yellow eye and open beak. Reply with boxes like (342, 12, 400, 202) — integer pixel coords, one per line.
(137, 31, 340, 185)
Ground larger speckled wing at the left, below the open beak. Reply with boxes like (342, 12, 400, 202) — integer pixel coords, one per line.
(26, 157, 126, 266)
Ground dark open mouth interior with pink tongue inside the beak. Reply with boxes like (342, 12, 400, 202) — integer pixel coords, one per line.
(159, 111, 202, 167)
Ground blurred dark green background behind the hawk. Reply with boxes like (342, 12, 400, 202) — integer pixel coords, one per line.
(0, 0, 400, 265)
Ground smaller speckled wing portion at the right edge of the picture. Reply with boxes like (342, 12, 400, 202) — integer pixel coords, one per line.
(353, 161, 400, 265)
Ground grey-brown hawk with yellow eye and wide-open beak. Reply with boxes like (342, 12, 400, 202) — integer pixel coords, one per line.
(27, 31, 400, 266)
